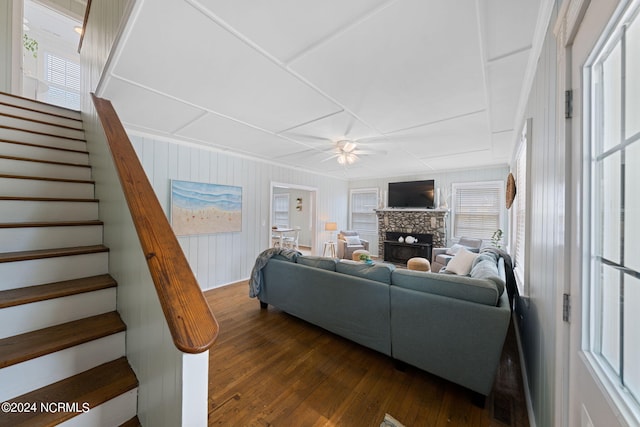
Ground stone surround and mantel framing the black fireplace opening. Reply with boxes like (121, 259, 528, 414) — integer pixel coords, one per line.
(376, 208, 449, 259)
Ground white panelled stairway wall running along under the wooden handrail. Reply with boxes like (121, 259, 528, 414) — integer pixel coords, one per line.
(81, 0, 208, 426)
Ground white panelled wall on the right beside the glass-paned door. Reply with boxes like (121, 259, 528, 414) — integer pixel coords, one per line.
(514, 5, 566, 426)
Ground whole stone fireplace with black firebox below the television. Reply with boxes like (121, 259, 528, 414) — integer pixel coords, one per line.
(376, 209, 448, 263)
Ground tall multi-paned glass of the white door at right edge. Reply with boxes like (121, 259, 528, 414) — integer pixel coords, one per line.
(584, 2, 640, 422)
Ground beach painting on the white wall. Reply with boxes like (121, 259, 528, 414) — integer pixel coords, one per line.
(171, 180, 242, 236)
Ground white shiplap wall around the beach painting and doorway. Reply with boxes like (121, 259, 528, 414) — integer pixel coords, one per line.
(130, 132, 348, 289)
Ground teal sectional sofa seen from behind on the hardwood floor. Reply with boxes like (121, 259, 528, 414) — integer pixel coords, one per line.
(252, 253, 511, 396)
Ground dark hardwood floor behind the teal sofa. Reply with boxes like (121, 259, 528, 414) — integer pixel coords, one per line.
(205, 282, 529, 427)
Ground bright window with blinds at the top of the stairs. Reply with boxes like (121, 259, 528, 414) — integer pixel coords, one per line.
(44, 52, 80, 110)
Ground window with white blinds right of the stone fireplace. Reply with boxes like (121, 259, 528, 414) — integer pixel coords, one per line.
(451, 181, 504, 240)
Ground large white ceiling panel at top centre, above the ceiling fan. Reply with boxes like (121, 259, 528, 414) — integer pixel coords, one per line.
(291, 0, 486, 133)
